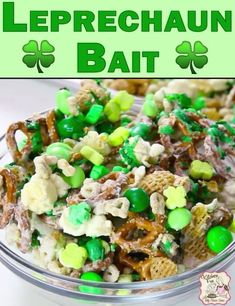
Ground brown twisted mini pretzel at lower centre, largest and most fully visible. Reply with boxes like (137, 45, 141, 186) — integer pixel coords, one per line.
(113, 216, 164, 255)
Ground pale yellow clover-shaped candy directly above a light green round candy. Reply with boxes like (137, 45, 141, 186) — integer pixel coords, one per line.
(163, 186, 186, 209)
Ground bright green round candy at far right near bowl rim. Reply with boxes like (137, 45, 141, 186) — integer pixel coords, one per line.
(206, 225, 233, 254)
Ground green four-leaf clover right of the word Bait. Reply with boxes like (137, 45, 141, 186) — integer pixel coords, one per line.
(175, 41, 208, 74)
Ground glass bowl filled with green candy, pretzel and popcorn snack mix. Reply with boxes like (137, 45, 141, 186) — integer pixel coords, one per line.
(0, 79, 235, 305)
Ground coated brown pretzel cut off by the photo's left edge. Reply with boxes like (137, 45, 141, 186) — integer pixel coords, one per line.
(0, 169, 16, 229)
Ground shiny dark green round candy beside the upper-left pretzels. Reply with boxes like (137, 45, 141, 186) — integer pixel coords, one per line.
(57, 114, 85, 139)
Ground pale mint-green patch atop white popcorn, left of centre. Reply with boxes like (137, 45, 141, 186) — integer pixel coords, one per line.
(68, 202, 91, 225)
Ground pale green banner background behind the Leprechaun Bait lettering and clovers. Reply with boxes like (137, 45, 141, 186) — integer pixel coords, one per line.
(0, 0, 235, 78)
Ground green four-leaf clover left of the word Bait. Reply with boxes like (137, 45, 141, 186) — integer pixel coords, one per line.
(22, 40, 55, 73)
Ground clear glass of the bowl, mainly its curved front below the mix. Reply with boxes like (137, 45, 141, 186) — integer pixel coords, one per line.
(0, 108, 235, 306)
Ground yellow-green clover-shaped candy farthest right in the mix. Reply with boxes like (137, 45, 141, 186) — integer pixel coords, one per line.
(189, 160, 214, 180)
